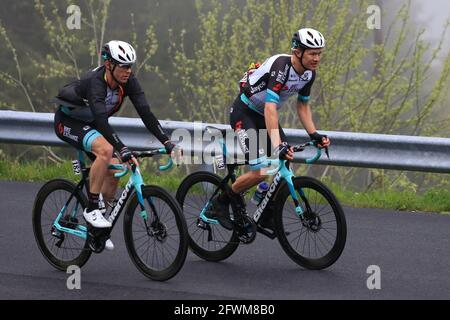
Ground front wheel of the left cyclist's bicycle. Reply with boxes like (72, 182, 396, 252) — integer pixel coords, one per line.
(123, 186, 188, 281)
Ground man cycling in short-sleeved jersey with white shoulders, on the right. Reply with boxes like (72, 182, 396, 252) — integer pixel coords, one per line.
(209, 28, 330, 229)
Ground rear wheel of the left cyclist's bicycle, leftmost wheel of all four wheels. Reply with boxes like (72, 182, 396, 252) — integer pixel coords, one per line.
(32, 179, 91, 271)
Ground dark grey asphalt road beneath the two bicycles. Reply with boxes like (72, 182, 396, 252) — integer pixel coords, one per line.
(0, 182, 450, 300)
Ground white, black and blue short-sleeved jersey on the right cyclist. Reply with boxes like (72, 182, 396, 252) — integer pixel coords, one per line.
(240, 54, 316, 115)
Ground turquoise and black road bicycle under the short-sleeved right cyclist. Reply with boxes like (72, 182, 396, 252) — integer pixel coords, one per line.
(176, 127, 347, 269)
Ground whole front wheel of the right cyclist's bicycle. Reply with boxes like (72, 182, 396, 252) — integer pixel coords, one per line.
(275, 177, 347, 270)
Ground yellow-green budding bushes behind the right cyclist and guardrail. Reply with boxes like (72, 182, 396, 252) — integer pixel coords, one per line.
(170, 0, 450, 186)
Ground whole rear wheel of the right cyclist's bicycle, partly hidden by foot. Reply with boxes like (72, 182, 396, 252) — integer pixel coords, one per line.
(176, 172, 239, 261)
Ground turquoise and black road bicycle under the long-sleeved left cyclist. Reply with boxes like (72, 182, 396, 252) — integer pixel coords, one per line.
(33, 149, 188, 281)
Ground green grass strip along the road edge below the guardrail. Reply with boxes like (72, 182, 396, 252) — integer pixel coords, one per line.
(0, 160, 450, 214)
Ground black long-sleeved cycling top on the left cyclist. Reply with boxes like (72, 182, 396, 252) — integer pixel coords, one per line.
(52, 66, 169, 151)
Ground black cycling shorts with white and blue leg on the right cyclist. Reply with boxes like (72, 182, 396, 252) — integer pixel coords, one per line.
(230, 96, 286, 166)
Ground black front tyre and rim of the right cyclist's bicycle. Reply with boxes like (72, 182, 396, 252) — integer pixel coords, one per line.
(274, 177, 347, 270)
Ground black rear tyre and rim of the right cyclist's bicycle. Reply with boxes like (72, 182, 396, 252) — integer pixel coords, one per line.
(176, 171, 239, 262)
